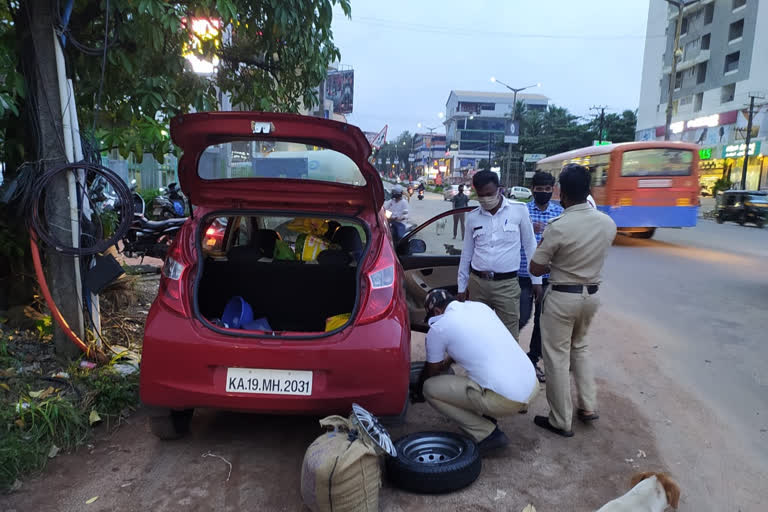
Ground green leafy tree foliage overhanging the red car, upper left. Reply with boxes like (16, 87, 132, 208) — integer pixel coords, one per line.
(0, 0, 350, 348)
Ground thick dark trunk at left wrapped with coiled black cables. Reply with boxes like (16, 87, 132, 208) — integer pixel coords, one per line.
(17, 0, 83, 358)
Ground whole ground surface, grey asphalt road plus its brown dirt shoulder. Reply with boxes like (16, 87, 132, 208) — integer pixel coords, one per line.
(6, 186, 768, 512)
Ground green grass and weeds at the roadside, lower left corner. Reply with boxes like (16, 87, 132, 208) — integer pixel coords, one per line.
(0, 335, 139, 492)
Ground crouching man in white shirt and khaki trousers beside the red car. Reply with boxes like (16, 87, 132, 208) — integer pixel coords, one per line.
(421, 289, 539, 455)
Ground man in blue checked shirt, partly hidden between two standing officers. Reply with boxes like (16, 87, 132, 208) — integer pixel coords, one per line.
(517, 171, 563, 382)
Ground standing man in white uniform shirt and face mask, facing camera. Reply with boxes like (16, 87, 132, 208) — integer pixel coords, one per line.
(458, 171, 541, 339)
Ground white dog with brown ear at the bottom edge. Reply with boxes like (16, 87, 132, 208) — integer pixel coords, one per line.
(597, 472, 680, 512)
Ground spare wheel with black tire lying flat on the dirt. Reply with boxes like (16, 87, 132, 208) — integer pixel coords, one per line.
(387, 432, 482, 494)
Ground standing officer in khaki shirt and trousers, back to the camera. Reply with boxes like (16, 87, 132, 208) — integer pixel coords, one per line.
(530, 164, 616, 437)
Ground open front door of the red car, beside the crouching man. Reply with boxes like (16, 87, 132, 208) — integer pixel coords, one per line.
(396, 207, 474, 332)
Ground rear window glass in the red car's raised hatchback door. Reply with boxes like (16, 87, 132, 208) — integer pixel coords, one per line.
(197, 140, 365, 187)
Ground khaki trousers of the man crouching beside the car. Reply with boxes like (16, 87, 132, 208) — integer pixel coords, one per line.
(424, 375, 539, 442)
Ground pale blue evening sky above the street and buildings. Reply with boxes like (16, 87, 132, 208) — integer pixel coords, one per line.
(333, 0, 663, 139)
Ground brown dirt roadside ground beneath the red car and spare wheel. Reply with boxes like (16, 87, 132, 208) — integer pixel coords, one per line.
(0, 258, 768, 512)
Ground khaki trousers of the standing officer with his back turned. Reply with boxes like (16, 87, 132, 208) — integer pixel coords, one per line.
(541, 286, 600, 431)
